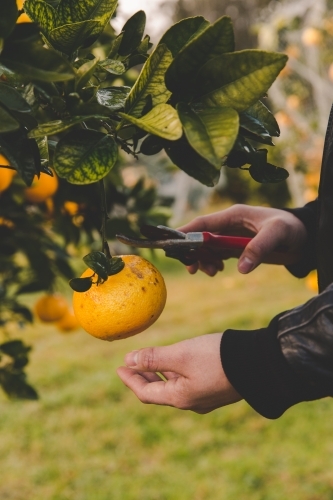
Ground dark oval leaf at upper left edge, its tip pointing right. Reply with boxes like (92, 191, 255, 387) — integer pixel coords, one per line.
(0, 41, 75, 82)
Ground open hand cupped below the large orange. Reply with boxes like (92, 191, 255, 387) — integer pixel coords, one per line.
(117, 333, 242, 414)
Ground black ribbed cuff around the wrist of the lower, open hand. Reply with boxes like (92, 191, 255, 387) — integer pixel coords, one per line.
(221, 316, 318, 419)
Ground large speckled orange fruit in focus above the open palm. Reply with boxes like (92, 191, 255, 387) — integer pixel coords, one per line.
(73, 255, 167, 341)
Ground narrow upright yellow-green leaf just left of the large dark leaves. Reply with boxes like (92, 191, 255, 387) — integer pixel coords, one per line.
(125, 45, 172, 118)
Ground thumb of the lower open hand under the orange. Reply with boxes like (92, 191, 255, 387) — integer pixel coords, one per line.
(125, 343, 184, 373)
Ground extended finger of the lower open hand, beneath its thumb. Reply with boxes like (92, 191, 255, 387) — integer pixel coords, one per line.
(117, 367, 174, 406)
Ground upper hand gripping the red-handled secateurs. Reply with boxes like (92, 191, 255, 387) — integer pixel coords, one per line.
(179, 205, 307, 276)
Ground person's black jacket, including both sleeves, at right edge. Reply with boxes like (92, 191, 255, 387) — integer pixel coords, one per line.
(221, 108, 333, 419)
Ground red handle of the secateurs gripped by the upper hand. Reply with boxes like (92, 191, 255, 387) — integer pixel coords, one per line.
(199, 232, 300, 266)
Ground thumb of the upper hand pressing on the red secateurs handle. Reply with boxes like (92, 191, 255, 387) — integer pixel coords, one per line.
(238, 224, 282, 274)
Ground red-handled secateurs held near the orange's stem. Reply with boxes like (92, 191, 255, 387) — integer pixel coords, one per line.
(116, 225, 298, 266)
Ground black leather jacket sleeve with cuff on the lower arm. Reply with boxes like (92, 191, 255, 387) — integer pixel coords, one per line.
(221, 284, 333, 419)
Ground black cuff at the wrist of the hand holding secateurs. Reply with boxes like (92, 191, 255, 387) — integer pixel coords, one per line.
(284, 200, 318, 278)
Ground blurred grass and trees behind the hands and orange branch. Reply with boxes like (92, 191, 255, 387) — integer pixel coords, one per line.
(0, 0, 333, 500)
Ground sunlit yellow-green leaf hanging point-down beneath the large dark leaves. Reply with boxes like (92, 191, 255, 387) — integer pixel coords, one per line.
(177, 103, 239, 168)
